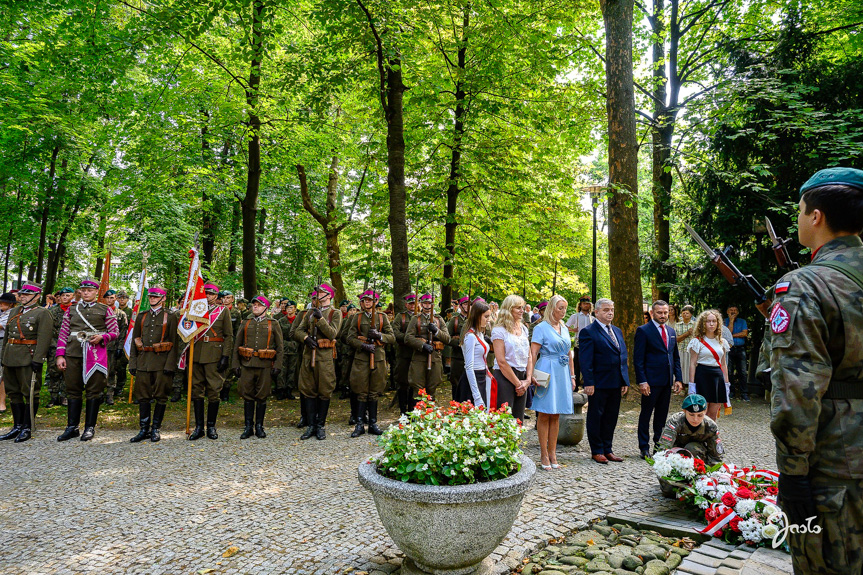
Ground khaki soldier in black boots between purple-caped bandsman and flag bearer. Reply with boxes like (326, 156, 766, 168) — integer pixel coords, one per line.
(129, 286, 177, 443)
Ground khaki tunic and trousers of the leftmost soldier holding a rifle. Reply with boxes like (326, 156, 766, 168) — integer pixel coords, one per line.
(294, 307, 342, 401)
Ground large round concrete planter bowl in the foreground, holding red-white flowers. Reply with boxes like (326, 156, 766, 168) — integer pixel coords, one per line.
(358, 455, 536, 575)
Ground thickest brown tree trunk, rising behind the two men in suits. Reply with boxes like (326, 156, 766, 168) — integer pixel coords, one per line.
(600, 0, 642, 383)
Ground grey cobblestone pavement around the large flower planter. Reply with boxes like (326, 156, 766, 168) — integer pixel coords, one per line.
(0, 398, 775, 575)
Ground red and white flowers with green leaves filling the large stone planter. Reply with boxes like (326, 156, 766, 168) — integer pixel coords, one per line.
(372, 390, 522, 485)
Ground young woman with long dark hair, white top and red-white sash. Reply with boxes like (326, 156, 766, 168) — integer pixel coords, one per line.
(459, 300, 497, 411)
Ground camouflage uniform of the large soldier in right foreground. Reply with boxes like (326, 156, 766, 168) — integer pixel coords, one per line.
(765, 236, 863, 575)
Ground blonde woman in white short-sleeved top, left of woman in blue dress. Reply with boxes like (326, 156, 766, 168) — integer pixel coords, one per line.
(491, 295, 533, 421)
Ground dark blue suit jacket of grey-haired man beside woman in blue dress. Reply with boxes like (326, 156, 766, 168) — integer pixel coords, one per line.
(578, 321, 629, 389)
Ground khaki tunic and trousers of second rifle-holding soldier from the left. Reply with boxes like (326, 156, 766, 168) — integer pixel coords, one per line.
(348, 312, 396, 402)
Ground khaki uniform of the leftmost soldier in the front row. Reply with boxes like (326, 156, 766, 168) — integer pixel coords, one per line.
(2, 305, 54, 403)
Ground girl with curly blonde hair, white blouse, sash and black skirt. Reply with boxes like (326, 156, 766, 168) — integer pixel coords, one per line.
(687, 309, 730, 421)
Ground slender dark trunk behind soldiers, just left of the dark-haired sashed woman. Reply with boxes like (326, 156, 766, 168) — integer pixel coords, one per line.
(441, 3, 471, 307)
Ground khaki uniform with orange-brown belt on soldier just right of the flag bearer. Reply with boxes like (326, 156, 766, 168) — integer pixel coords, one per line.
(232, 314, 285, 402)
